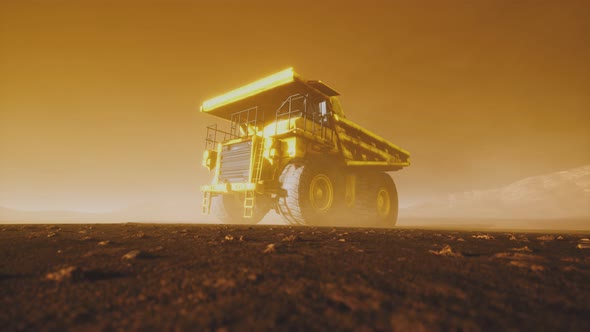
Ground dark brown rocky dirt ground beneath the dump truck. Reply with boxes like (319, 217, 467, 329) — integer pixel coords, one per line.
(0, 224, 590, 331)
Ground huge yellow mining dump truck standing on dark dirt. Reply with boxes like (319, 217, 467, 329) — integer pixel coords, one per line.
(201, 68, 410, 226)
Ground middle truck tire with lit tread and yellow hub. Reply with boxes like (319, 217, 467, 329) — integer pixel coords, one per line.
(277, 161, 342, 226)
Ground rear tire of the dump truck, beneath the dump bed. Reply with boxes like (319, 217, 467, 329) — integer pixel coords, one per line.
(352, 173, 399, 227)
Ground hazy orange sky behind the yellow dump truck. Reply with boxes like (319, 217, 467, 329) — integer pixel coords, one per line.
(0, 0, 590, 211)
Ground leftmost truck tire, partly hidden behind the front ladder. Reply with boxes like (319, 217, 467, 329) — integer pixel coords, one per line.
(211, 194, 271, 225)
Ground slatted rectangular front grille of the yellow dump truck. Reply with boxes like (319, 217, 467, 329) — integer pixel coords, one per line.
(219, 141, 252, 183)
